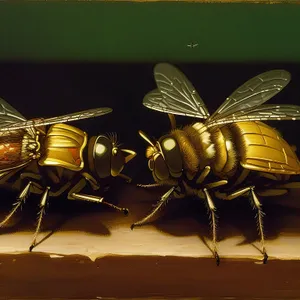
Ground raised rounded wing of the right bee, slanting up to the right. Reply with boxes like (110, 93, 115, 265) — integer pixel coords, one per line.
(207, 70, 291, 123)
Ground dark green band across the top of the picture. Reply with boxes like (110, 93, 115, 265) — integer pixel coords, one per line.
(0, 2, 300, 62)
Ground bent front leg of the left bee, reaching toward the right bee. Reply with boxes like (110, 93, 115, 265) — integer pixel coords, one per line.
(68, 178, 129, 215)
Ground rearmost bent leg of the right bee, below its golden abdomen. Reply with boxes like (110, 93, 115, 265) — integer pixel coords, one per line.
(216, 186, 268, 264)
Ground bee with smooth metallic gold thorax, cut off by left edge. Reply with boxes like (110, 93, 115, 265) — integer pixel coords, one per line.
(0, 99, 136, 251)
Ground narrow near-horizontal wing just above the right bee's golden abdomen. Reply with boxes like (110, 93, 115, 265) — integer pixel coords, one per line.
(207, 104, 300, 127)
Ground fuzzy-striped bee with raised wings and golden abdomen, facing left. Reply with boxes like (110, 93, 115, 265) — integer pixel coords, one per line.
(131, 63, 300, 264)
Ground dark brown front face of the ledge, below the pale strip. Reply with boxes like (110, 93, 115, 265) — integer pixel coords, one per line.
(0, 253, 300, 299)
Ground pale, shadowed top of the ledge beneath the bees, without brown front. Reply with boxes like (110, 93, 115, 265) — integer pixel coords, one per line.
(0, 186, 300, 261)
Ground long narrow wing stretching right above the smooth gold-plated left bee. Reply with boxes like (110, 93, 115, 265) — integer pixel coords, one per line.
(0, 107, 112, 132)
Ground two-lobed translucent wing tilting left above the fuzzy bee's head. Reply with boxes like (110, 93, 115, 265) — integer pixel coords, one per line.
(143, 63, 209, 119)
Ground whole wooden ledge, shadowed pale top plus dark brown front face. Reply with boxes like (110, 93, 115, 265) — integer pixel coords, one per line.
(0, 186, 300, 299)
